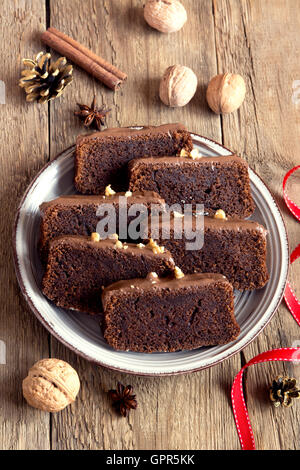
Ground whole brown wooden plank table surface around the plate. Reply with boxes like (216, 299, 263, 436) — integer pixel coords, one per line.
(0, 0, 300, 449)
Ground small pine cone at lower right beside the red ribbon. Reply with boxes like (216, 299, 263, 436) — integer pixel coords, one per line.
(270, 375, 300, 407)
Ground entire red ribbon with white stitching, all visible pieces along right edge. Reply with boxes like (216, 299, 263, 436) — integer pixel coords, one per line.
(231, 165, 300, 450)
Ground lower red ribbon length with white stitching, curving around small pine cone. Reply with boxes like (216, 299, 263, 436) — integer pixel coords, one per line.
(231, 348, 300, 450)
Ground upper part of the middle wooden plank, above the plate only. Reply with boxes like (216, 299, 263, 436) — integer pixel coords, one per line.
(50, 0, 221, 157)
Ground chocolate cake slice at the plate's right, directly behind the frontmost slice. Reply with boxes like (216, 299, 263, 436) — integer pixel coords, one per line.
(143, 216, 269, 290)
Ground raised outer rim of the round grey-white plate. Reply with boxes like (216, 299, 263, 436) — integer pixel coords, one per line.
(12, 132, 289, 377)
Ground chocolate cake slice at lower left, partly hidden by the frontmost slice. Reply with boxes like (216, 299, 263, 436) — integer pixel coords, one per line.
(42, 234, 174, 313)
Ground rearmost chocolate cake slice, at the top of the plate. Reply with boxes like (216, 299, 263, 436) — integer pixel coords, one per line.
(75, 124, 193, 194)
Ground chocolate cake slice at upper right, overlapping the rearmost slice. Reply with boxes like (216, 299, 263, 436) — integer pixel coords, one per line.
(129, 155, 254, 218)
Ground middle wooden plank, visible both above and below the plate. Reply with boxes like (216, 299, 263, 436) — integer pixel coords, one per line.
(50, 0, 240, 449)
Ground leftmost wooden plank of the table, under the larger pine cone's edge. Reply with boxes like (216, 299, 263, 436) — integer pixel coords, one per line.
(0, 0, 50, 449)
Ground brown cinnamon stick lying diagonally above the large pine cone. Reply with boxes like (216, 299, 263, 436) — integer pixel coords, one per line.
(42, 28, 127, 90)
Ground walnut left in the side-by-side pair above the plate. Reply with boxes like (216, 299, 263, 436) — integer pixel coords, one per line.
(159, 65, 198, 108)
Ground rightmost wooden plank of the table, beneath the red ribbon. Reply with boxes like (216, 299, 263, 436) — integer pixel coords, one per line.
(214, 0, 300, 449)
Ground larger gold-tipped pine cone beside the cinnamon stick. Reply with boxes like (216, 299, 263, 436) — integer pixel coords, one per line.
(19, 52, 73, 103)
